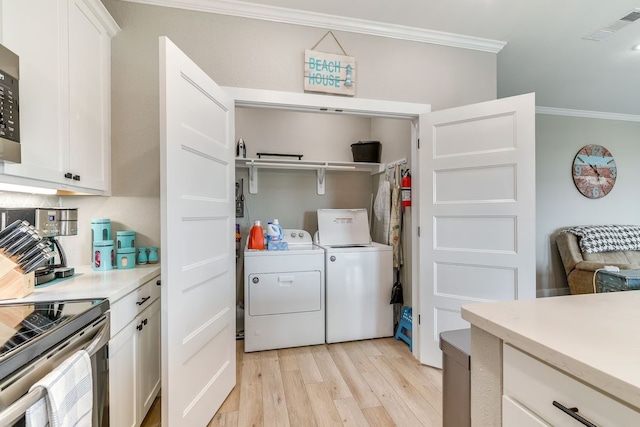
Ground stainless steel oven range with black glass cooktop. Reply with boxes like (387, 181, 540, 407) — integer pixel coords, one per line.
(0, 300, 110, 427)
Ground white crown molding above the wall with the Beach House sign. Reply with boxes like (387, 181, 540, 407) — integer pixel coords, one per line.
(123, 0, 507, 53)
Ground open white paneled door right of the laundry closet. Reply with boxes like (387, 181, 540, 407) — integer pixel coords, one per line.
(418, 94, 536, 367)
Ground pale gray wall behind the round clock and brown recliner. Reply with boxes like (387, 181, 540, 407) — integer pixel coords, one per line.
(536, 114, 640, 296)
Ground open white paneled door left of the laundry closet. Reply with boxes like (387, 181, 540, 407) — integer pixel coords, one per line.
(160, 37, 236, 426)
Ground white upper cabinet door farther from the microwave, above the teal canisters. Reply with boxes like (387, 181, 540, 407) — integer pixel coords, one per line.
(67, 0, 111, 190)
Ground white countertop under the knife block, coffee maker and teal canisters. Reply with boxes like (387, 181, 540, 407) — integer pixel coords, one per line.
(0, 264, 160, 304)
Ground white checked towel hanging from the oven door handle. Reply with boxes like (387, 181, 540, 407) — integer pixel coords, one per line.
(25, 350, 93, 427)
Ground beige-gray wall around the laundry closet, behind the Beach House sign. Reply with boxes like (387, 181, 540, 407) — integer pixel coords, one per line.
(63, 0, 496, 272)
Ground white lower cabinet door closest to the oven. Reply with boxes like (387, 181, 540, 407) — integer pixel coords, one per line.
(109, 319, 138, 427)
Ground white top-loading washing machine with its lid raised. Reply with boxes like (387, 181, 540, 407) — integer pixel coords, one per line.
(316, 209, 393, 343)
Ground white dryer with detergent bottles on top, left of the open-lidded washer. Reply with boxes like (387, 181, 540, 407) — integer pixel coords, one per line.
(244, 229, 325, 352)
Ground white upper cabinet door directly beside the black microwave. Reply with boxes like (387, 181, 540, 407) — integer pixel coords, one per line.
(1, 0, 69, 182)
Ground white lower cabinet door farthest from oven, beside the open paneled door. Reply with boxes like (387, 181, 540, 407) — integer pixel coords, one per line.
(136, 299, 160, 422)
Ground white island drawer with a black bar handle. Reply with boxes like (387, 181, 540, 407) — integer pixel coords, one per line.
(503, 345, 640, 427)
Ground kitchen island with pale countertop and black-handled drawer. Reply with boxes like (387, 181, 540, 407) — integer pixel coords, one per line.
(462, 291, 640, 426)
